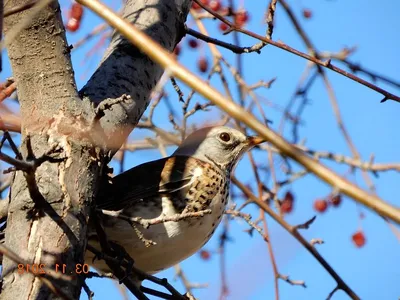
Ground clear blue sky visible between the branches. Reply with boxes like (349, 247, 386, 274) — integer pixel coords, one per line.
(1, 0, 400, 300)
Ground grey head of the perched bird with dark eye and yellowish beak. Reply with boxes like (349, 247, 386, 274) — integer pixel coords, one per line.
(173, 126, 265, 172)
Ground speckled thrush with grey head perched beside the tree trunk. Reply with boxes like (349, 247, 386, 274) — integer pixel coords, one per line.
(85, 126, 265, 274)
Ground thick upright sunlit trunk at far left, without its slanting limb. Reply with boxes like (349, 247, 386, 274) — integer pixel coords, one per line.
(1, 0, 90, 299)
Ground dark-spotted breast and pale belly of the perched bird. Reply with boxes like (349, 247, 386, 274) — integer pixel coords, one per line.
(89, 176, 229, 273)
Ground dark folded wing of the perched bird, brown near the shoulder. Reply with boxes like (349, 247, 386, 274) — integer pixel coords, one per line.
(96, 156, 205, 210)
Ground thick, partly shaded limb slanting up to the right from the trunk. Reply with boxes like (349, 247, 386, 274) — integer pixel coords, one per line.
(80, 0, 191, 152)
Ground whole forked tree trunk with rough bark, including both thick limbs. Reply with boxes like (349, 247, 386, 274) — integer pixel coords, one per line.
(1, 0, 191, 299)
